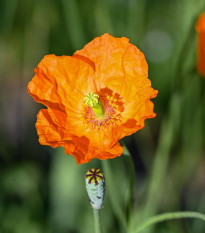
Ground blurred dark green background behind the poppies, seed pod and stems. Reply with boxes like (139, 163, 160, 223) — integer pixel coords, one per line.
(0, 0, 205, 233)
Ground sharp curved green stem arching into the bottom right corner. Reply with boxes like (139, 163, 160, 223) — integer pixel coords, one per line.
(134, 211, 205, 233)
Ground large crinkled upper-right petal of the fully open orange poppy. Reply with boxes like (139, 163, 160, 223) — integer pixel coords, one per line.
(75, 34, 158, 140)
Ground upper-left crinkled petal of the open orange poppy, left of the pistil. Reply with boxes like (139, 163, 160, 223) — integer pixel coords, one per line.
(28, 55, 96, 111)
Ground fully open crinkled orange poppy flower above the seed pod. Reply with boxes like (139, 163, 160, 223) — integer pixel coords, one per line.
(28, 34, 158, 164)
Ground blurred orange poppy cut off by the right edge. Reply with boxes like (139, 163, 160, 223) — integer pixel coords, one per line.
(196, 13, 205, 77)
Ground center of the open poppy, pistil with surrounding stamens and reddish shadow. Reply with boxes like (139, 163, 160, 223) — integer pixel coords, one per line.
(82, 88, 124, 130)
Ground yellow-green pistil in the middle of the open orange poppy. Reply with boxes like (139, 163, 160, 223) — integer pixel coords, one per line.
(84, 92, 104, 118)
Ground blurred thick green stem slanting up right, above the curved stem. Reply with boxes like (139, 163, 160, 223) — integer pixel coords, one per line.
(140, 94, 181, 220)
